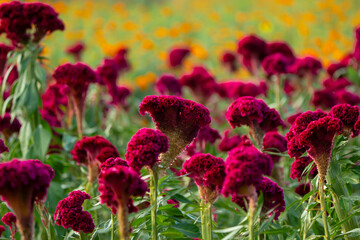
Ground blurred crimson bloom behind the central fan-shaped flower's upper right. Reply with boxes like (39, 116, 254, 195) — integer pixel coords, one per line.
(179, 66, 217, 102)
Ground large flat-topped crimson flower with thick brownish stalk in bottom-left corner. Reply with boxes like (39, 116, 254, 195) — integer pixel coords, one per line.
(0, 159, 55, 239)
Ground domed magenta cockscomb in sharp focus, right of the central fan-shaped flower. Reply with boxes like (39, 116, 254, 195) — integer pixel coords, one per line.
(226, 97, 285, 146)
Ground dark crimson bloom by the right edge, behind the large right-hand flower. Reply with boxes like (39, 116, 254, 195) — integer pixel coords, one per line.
(329, 103, 360, 137)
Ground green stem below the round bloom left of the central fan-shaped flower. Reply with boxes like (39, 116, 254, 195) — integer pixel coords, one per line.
(150, 166, 158, 240)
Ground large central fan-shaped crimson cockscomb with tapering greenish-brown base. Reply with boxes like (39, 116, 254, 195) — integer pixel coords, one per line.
(139, 96, 211, 166)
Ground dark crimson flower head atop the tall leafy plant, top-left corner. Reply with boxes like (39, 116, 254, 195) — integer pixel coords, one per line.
(0, 1, 65, 46)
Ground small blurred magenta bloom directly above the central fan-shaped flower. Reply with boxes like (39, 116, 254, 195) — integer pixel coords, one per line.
(155, 74, 182, 96)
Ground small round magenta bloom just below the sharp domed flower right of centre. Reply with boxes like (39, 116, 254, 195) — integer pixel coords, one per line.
(263, 132, 287, 163)
